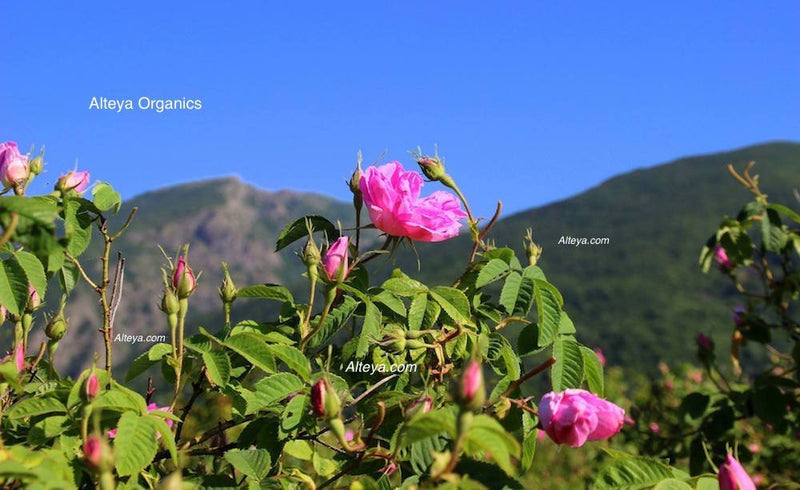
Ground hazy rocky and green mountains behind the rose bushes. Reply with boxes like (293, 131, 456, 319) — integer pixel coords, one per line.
(45, 143, 800, 373)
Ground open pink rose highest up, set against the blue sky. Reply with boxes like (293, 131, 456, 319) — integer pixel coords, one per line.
(359, 162, 467, 242)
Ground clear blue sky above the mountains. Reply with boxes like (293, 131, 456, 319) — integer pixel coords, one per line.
(0, 1, 800, 215)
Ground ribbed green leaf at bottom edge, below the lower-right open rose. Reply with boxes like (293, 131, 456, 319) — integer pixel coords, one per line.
(594, 457, 688, 490)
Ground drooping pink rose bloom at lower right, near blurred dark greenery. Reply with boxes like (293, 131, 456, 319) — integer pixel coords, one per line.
(539, 389, 625, 447)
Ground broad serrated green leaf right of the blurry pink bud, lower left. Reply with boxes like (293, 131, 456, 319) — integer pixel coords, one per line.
(114, 412, 158, 476)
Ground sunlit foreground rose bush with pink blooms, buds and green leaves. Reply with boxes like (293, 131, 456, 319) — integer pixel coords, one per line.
(0, 143, 780, 488)
